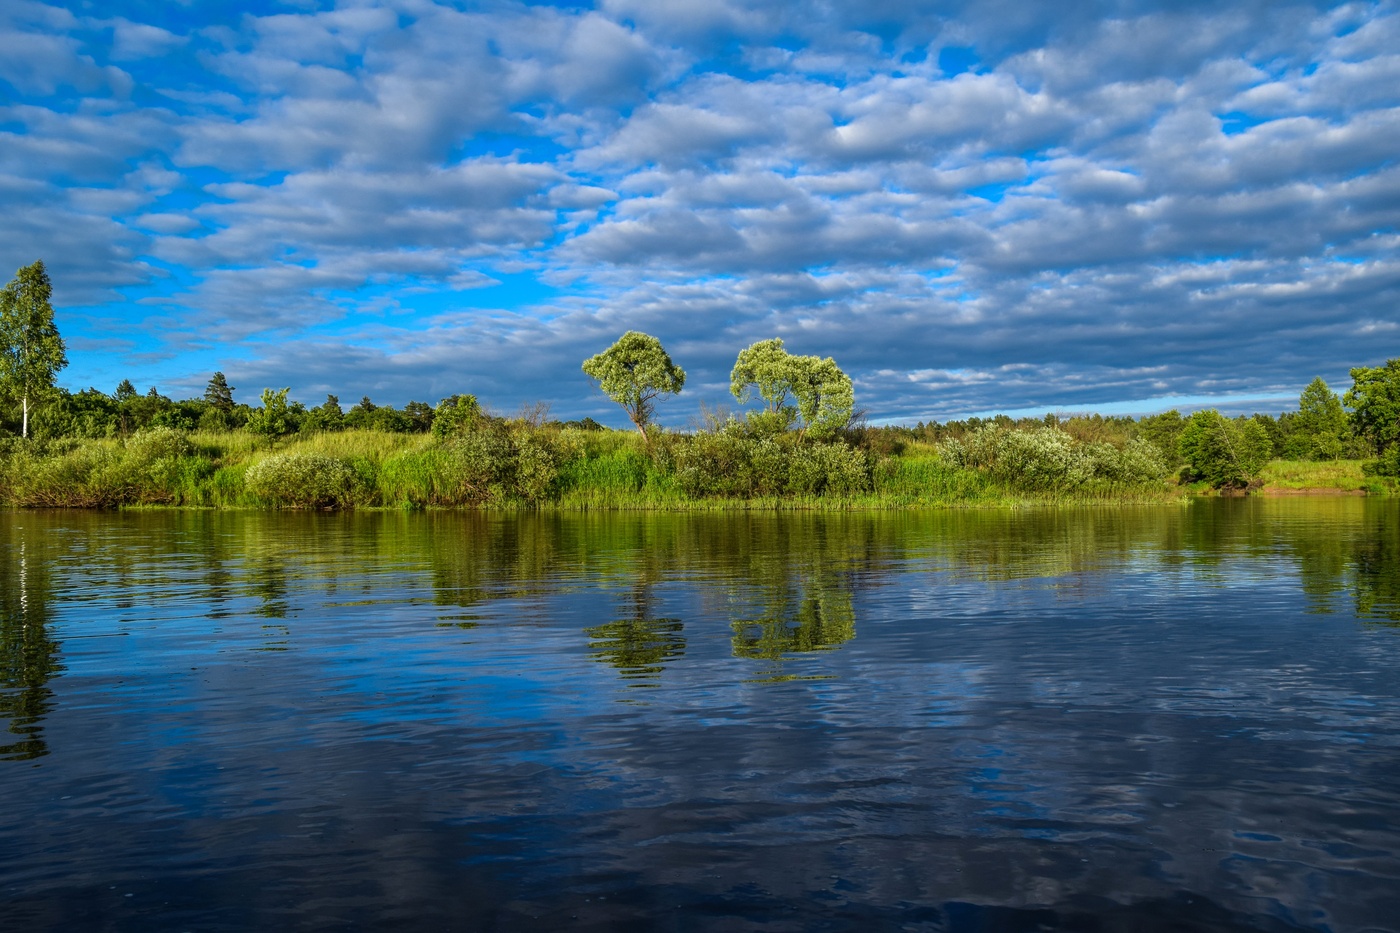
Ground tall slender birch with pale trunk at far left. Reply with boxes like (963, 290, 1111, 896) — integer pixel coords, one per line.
(0, 259, 69, 437)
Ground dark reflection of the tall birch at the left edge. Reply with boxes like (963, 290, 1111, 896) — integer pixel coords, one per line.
(0, 529, 63, 759)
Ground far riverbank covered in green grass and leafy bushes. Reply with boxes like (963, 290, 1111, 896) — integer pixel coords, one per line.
(0, 424, 1394, 511)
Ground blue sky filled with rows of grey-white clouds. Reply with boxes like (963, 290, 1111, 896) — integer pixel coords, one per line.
(0, 0, 1400, 426)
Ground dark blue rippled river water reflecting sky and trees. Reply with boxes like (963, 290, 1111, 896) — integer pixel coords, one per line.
(0, 499, 1400, 932)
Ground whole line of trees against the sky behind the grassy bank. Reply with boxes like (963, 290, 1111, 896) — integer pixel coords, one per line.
(0, 261, 1400, 486)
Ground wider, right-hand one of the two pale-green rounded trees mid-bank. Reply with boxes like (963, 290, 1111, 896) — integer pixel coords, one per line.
(729, 338, 855, 437)
